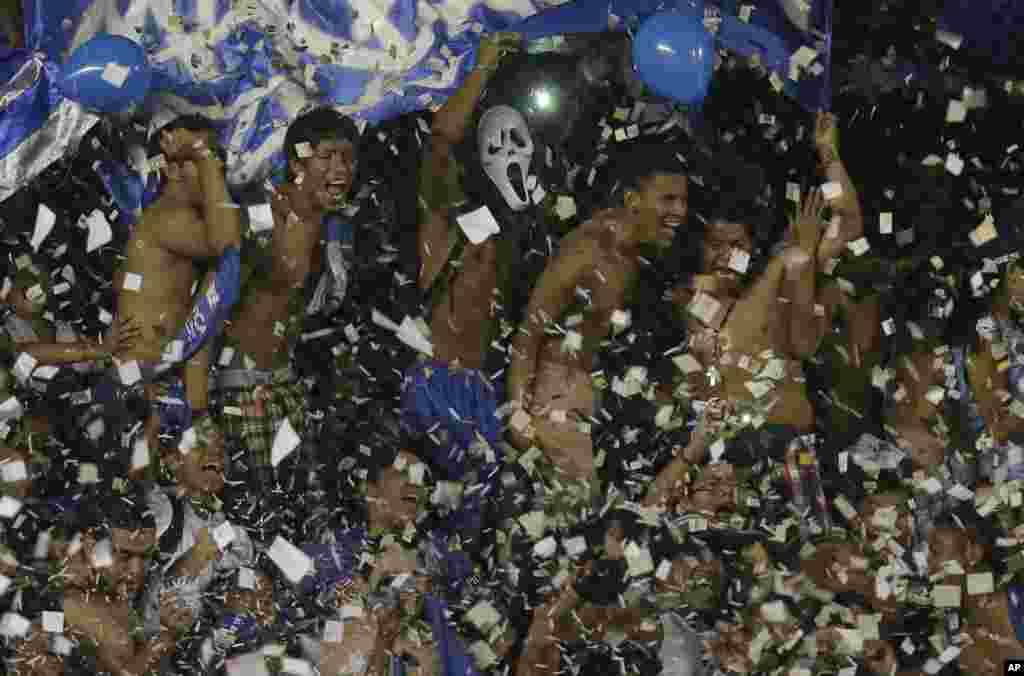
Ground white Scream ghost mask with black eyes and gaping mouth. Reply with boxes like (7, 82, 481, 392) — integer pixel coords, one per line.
(476, 105, 534, 211)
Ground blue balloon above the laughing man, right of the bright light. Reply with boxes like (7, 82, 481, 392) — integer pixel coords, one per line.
(633, 11, 715, 103)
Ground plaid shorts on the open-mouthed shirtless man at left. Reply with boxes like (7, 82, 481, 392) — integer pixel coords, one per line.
(217, 381, 308, 468)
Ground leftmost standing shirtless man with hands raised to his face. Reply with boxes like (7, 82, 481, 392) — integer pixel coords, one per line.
(115, 118, 241, 449)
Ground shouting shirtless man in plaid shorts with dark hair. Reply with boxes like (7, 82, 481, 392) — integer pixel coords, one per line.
(216, 109, 359, 472)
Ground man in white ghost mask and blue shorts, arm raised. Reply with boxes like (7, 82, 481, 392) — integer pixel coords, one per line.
(402, 35, 532, 491)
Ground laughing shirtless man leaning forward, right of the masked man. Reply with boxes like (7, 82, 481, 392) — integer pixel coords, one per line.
(508, 143, 688, 478)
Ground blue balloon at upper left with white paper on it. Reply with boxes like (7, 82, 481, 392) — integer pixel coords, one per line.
(60, 33, 153, 113)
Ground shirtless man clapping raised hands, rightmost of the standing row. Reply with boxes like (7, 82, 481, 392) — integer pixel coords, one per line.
(647, 188, 828, 524)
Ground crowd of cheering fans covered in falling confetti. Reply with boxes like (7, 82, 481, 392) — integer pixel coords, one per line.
(0, 19, 1024, 676)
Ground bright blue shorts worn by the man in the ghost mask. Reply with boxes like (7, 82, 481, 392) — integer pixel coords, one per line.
(401, 360, 501, 480)
